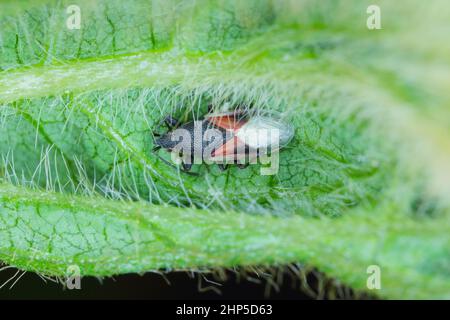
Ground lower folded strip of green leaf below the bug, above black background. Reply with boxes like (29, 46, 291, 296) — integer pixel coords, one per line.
(0, 185, 450, 298)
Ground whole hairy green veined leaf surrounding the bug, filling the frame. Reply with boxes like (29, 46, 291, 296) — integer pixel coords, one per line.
(0, 0, 450, 298)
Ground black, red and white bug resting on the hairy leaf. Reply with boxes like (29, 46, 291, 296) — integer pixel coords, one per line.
(153, 105, 294, 172)
